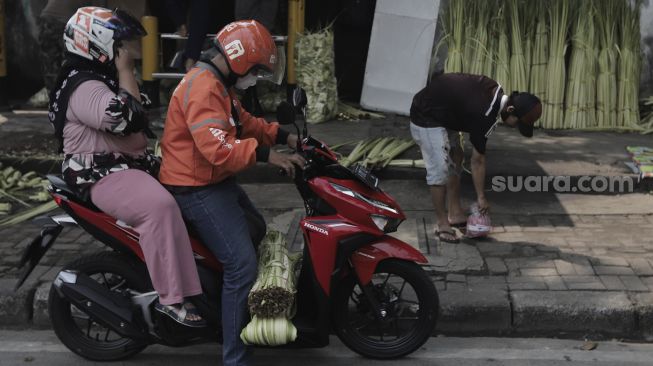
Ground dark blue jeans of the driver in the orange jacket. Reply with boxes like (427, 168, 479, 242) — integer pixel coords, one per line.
(174, 179, 265, 366)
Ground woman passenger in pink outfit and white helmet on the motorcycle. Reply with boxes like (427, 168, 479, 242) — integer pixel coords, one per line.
(49, 7, 205, 327)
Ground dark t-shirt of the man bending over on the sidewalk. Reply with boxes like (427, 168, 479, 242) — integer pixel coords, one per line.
(410, 73, 503, 154)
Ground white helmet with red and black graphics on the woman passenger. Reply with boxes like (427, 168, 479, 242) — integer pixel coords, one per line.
(63, 6, 147, 64)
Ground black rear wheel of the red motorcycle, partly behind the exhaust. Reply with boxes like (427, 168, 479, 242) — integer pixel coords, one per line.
(48, 252, 149, 361)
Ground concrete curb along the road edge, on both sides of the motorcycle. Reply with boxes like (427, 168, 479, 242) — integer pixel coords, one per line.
(5, 279, 653, 341)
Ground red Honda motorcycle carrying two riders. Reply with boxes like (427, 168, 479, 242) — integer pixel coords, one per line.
(17, 90, 438, 361)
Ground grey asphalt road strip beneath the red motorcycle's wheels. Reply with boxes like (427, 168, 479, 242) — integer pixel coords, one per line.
(0, 330, 653, 366)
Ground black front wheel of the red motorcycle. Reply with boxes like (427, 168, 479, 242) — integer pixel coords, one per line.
(332, 259, 439, 359)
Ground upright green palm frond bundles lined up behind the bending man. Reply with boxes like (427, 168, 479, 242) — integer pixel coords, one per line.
(440, 0, 645, 131)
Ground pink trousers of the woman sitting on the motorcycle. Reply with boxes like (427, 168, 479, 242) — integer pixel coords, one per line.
(91, 169, 202, 305)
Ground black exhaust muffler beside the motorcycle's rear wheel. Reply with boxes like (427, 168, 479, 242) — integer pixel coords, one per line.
(54, 270, 148, 340)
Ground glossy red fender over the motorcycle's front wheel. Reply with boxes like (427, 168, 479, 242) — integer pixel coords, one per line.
(351, 235, 428, 285)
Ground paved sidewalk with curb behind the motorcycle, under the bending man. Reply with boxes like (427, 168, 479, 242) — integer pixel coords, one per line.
(0, 111, 653, 339)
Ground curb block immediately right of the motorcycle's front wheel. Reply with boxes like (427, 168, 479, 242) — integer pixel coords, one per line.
(436, 290, 511, 335)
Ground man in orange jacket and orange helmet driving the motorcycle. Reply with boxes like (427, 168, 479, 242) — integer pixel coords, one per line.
(159, 20, 305, 365)
